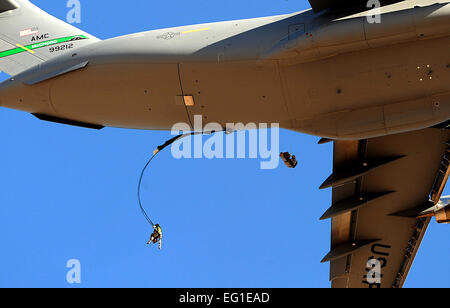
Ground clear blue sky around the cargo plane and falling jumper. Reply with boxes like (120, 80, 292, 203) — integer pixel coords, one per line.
(0, 0, 450, 287)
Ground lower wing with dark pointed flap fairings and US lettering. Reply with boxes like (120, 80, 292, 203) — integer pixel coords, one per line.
(321, 128, 450, 288)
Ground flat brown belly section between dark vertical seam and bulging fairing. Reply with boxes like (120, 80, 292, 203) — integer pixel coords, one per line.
(181, 62, 291, 127)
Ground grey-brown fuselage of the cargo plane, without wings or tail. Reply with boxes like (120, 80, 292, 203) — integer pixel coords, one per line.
(0, 0, 450, 139)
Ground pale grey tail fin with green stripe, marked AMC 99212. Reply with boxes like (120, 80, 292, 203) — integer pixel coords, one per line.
(0, 0, 99, 76)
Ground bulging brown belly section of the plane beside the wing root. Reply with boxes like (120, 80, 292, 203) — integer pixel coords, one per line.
(282, 37, 450, 139)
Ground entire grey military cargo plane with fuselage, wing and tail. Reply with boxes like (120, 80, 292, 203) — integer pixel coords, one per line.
(0, 0, 450, 288)
